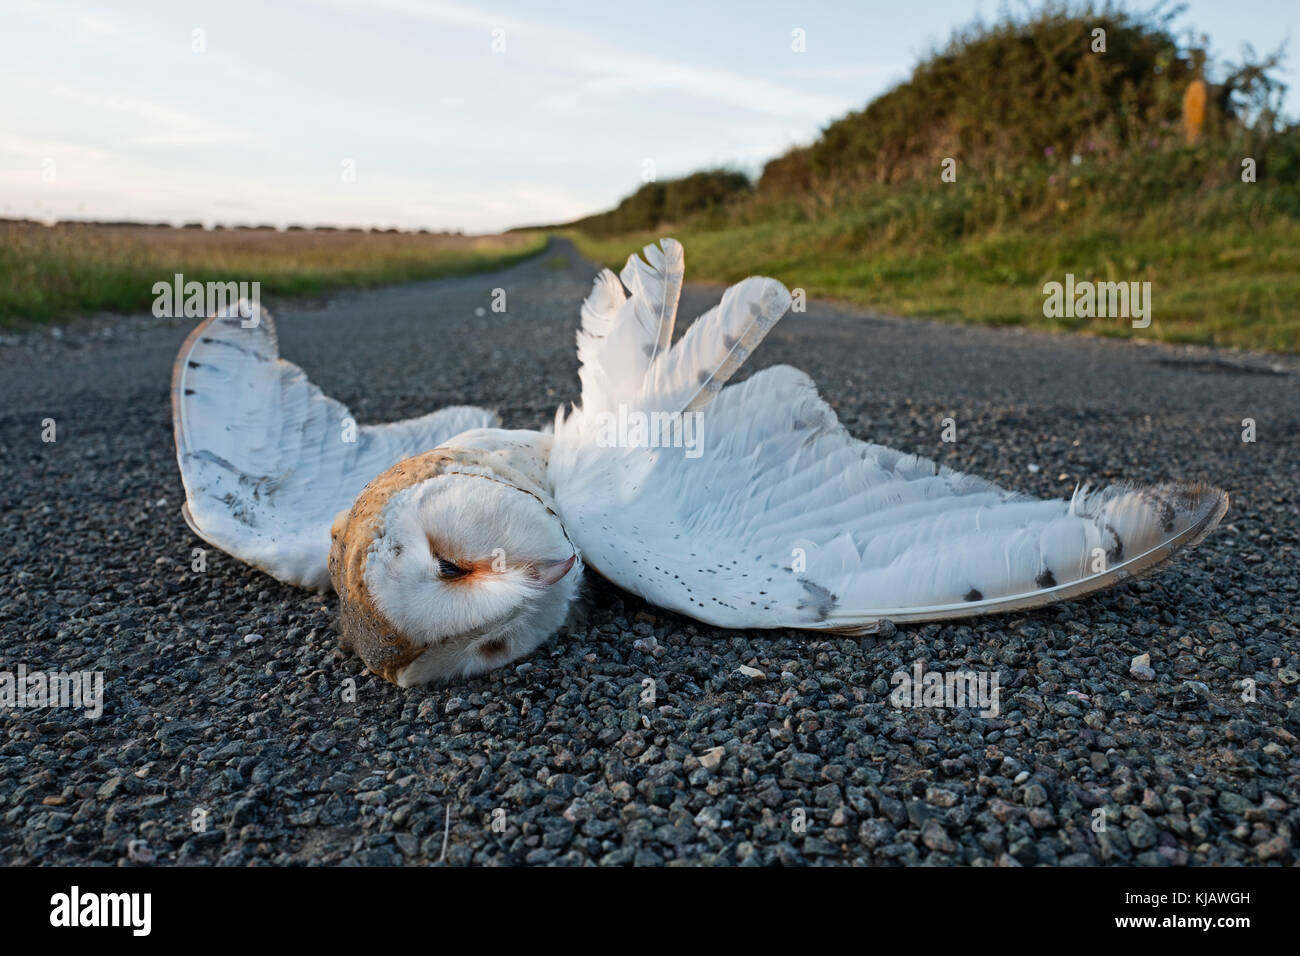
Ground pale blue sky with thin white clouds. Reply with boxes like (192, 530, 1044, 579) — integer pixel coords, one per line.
(0, 0, 1300, 232)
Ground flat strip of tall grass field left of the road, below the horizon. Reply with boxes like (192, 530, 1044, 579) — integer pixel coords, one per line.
(0, 221, 546, 326)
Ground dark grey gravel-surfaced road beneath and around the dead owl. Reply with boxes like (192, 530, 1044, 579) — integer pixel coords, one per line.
(0, 242, 1300, 866)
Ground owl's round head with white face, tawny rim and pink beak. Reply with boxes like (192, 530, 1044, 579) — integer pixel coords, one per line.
(329, 447, 582, 687)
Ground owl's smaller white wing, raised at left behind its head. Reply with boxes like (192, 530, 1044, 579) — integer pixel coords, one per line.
(172, 303, 499, 589)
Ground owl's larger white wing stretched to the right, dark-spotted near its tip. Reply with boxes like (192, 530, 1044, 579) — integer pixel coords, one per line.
(550, 239, 1227, 632)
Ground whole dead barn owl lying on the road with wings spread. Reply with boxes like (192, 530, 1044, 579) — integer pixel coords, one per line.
(172, 239, 1229, 687)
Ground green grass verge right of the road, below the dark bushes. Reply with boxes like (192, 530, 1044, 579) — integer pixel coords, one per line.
(568, 174, 1300, 352)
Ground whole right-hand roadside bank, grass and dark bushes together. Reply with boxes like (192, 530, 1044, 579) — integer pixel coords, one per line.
(569, 0, 1300, 352)
